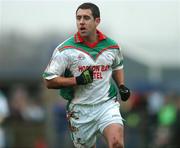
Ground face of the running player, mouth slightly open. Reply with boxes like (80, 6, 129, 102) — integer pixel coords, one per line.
(76, 9, 100, 37)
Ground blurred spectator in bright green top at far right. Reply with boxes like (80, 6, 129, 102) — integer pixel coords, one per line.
(154, 92, 177, 148)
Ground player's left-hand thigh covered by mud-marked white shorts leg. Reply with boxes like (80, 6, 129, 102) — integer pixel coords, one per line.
(68, 105, 97, 148)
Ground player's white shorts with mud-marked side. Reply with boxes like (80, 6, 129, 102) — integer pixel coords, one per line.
(67, 100, 123, 148)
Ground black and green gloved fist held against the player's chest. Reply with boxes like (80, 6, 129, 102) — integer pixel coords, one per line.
(76, 67, 93, 85)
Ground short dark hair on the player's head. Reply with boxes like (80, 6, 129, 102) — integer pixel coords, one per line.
(76, 3, 100, 19)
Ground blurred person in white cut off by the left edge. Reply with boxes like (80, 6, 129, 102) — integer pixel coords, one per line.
(0, 91, 9, 148)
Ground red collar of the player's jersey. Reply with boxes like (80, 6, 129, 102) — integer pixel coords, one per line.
(74, 30, 107, 48)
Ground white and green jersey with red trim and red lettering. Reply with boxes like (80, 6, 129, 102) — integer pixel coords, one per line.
(43, 31, 123, 104)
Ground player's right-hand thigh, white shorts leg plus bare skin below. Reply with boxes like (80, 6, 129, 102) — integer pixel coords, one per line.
(99, 100, 124, 148)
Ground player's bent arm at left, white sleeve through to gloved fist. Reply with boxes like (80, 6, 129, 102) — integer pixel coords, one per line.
(43, 48, 93, 89)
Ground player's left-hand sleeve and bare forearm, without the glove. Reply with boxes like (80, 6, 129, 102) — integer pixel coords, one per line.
(43, 49, 76, 89)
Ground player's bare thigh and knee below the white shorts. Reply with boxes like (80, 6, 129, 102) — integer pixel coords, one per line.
(103, 123, 124, 148)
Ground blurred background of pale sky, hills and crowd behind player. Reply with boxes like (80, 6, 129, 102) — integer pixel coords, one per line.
(0, 0, 180, 148)
